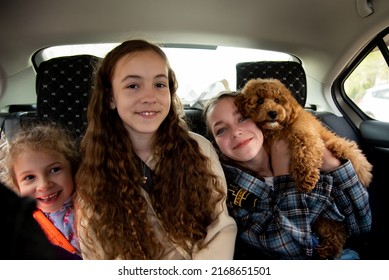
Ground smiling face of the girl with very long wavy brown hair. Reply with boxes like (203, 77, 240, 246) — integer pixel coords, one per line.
(111, 51, 171, 139)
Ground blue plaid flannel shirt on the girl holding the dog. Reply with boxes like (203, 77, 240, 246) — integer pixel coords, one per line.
(224, 161, 372, 259)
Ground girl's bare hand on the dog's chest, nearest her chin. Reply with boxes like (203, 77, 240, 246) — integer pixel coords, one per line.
(270, 140, 290, 176)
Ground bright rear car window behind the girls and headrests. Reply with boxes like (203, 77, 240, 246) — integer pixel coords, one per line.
(32, 43, 300, 107)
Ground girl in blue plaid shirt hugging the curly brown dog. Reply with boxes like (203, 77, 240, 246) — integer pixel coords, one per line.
(204, 92, 372, 259)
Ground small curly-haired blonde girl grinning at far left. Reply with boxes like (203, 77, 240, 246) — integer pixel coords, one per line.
(4, 124, 80, 255)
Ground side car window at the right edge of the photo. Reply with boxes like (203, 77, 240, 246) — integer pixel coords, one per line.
(344, 32, 389, 122)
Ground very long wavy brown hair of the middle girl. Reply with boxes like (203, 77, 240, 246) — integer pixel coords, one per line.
(76, 40, 225, 259)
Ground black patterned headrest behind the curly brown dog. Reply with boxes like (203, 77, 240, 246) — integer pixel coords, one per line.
(236, 61, 307, 107)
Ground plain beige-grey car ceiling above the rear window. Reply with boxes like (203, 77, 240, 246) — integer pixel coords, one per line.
(0, 0, 389, 86)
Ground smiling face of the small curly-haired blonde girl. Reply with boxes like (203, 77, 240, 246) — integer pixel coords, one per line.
(13, 148, 74, 212)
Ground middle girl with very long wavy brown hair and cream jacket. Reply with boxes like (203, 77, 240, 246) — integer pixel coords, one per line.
(76, 40, 236, 259)
